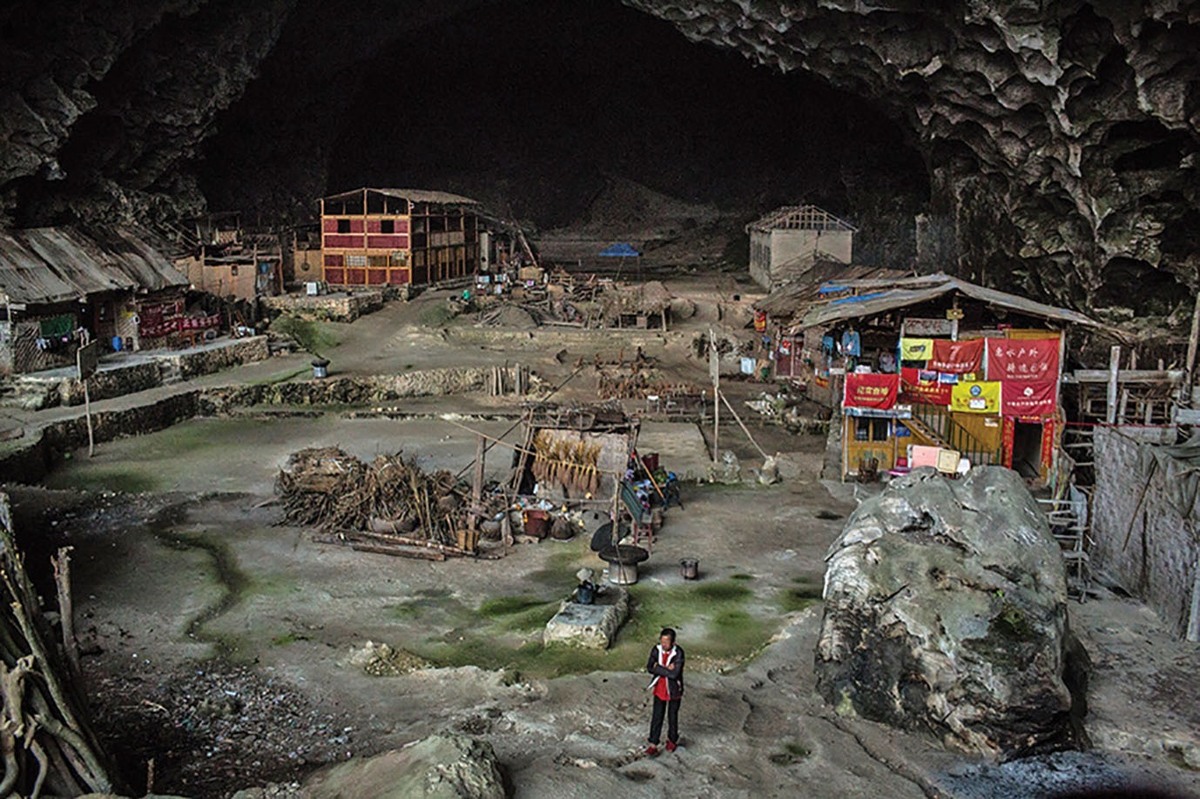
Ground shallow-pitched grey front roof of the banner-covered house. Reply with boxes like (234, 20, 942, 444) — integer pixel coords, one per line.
(798, 275, 1102, 328)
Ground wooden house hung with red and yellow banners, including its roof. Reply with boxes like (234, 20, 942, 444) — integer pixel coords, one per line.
(772, 275, 1098, 486)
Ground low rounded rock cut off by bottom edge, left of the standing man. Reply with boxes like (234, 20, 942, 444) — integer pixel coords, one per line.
(304, 733, 506, 799)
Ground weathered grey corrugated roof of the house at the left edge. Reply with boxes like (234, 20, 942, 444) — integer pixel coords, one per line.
(0, 228, 187, 305)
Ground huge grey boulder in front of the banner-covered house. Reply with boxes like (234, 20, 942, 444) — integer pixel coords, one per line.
(816, 467, 1086, 758)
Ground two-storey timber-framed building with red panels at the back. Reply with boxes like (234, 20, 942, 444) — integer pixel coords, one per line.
(320, 188, 480, 287)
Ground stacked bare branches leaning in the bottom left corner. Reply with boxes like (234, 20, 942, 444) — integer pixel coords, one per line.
(0, 494, 113, 798)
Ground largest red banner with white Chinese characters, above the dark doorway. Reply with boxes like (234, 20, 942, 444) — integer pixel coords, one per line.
(988, 338, 1058, 416)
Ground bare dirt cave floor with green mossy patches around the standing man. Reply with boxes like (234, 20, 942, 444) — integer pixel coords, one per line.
(13, 286, 1200, 798)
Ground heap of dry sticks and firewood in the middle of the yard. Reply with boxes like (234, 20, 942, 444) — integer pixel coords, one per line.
(275, 447, 487, 560)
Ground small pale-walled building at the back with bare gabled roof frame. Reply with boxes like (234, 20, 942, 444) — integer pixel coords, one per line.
(746, 205, 857, 290)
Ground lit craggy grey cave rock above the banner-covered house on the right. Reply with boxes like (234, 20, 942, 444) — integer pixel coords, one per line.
(624, 0, 1200, 307)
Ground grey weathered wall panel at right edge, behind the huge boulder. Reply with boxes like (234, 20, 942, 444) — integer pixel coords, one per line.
(1091, 428, 1200, 636)
